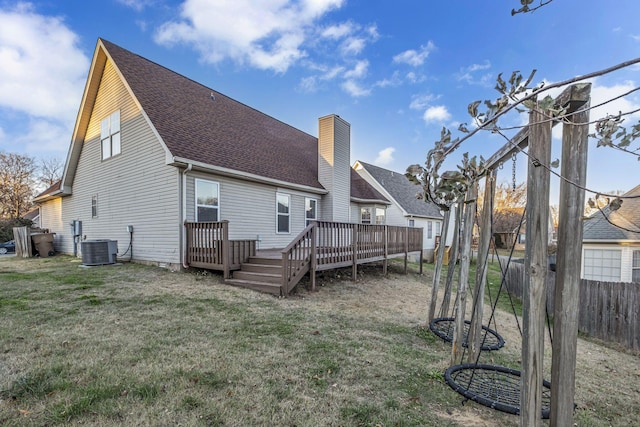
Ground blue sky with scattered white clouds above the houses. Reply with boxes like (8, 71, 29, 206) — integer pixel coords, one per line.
(0, 0, 640, 204)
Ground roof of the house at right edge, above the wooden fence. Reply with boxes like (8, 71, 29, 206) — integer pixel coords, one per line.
(582, 185, 640, 241)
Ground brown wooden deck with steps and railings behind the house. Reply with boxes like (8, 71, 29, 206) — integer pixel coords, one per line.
(185, 221, 422, 296)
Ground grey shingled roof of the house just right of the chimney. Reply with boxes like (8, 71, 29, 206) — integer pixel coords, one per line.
(358, 161, 442, 218)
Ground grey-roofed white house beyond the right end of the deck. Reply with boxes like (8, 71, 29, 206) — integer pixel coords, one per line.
(353, 160, 453, 262)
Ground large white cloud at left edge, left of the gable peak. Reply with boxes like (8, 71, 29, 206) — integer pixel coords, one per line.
(0, 3, 90, 156)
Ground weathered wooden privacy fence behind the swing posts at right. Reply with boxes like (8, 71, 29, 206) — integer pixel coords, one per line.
(501, 260, 640, 350)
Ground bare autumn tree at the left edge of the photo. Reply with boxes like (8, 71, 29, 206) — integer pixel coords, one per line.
(0, 152, 36, 218)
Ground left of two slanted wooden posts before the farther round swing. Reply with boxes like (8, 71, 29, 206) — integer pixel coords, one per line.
(451, 181, 478, 366)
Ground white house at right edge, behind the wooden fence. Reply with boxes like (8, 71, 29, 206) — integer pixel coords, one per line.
(582, 185, 640, 283)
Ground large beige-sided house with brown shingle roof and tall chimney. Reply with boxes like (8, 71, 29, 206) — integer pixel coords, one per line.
(36, 39, 396, 267)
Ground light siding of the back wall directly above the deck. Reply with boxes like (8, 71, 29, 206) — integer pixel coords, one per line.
(187, 172, 322, 249)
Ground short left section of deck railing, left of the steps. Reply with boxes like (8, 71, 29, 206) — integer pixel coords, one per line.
(184, 221, 256, 279)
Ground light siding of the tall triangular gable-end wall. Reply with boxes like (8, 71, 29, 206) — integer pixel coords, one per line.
(60, 61, 182, 264)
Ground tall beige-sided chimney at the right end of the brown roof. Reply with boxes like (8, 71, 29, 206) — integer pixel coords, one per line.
(318, 115, 351, 222)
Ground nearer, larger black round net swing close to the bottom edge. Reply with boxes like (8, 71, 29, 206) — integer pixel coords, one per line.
(444, 363, 551, 419)
